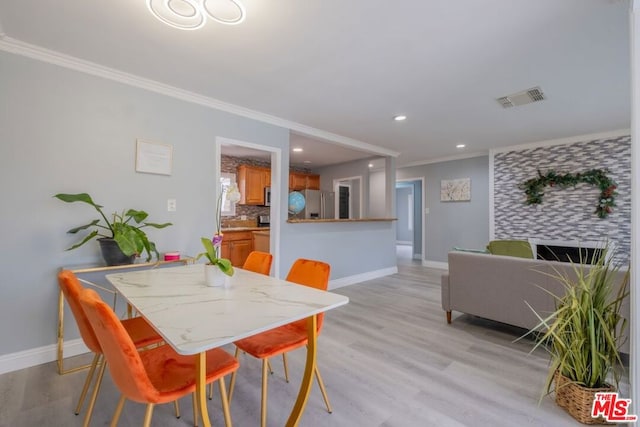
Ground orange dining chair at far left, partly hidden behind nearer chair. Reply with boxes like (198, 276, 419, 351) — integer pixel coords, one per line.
(58, 270, 164, 427)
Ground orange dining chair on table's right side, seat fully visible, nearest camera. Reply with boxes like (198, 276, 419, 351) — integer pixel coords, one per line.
(229, 259, 332, 427)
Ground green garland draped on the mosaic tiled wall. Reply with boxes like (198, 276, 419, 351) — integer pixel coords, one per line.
(518, 169, 618, 218)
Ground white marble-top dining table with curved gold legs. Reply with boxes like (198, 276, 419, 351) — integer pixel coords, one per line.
(106, 264, 349, 427)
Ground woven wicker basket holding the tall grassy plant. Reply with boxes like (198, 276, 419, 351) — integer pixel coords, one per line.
(555, 372, 616, 425)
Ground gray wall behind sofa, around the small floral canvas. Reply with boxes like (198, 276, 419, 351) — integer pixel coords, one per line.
(396, 156, 489, 262)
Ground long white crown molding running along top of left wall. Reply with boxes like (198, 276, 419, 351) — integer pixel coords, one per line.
(0, 35, 400, 157)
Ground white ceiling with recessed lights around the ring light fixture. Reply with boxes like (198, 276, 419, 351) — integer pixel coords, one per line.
(0, 0, 631, 166)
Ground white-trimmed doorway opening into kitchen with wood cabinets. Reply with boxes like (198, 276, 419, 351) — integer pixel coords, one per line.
(214, 137, 282, 277)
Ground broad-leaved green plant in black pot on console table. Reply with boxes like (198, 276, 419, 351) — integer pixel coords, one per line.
(54, 193, 172, 265)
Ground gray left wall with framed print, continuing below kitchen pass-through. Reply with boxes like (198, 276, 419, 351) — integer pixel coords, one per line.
(0, 52, 395, 355)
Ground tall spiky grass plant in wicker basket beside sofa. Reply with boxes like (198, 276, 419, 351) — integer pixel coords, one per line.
(527, 251, 629, 424)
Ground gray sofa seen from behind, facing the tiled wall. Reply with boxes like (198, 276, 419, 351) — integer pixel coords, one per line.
(441, 251, 629, 353)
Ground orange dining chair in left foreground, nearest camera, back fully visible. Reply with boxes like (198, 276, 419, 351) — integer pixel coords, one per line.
(80, 289, 239, 427)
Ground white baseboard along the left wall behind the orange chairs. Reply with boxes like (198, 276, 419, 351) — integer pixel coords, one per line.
(0, 338, 89, 374)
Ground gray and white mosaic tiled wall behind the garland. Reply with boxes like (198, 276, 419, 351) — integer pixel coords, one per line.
(493, 136, 631, 261)
